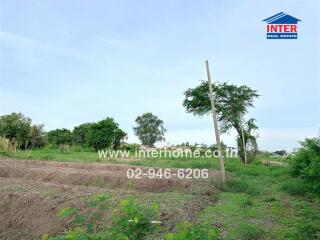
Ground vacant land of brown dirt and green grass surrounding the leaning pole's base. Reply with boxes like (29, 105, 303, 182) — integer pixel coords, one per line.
(0, 155, 320, 239)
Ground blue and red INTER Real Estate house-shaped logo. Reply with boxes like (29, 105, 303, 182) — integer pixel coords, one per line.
(263, 12, 301, 39)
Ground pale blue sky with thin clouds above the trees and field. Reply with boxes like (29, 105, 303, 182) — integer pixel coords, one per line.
(0, 0, 320, 150)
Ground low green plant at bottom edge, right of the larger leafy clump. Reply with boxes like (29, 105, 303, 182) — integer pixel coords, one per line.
(166, 222, 218, 240)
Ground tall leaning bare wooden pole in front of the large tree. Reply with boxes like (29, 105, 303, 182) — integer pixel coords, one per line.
(206, 60, 226, 183)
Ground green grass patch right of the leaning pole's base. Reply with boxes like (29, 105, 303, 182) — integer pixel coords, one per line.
(199, 161, 320, 240)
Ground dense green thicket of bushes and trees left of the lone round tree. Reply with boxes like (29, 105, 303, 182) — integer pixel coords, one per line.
(0, 113, 127, 152)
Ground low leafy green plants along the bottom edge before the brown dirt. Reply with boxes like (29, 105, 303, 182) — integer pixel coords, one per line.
(42, 194, 218, 240)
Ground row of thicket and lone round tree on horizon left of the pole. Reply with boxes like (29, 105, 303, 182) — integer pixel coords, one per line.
(0, 112, 166, 150)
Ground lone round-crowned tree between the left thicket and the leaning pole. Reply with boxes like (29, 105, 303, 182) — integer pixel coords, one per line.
(133, 112, 167, 147)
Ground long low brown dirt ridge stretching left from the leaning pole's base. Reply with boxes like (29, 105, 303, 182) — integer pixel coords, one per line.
(0, 159, 218, 192)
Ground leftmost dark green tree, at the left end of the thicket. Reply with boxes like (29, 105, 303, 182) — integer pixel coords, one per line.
(0, 113, 31, 148)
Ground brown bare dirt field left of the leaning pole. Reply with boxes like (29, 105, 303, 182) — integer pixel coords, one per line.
(0, 159, 219, 239)
